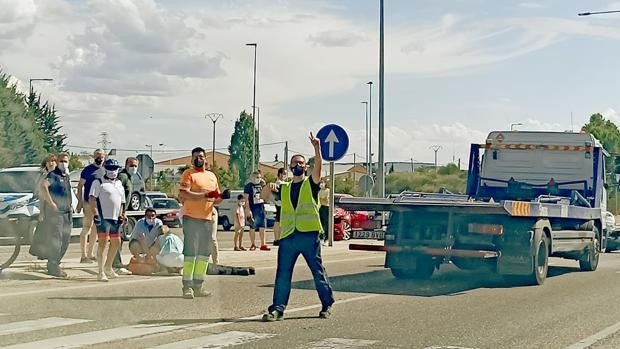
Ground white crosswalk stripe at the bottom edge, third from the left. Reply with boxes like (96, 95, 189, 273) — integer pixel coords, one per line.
(152, 331, 275, 349)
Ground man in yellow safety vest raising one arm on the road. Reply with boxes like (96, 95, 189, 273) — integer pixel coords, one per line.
(262, 132, 334, 321)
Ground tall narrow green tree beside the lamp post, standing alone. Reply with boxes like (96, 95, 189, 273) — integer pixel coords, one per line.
(228, 110, 260, 186)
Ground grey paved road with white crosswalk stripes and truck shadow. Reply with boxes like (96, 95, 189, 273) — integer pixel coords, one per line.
(0, 233, 620, 349)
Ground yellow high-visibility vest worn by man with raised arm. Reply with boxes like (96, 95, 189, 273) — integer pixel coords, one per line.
(280, 177, 323, 239)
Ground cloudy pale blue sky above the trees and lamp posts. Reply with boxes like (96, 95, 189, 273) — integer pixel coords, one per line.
(0, 0, 620, 164)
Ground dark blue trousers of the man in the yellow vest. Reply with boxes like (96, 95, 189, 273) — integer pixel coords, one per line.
(268, 231, 334, 314)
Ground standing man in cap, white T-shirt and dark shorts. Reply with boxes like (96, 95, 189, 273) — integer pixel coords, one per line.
(88, 159, 127, 281)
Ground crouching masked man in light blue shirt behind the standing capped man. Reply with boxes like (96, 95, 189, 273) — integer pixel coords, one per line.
(129, 207, 168, 258)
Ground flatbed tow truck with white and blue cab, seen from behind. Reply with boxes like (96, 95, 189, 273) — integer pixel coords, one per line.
(336, 131, 608, 285)
